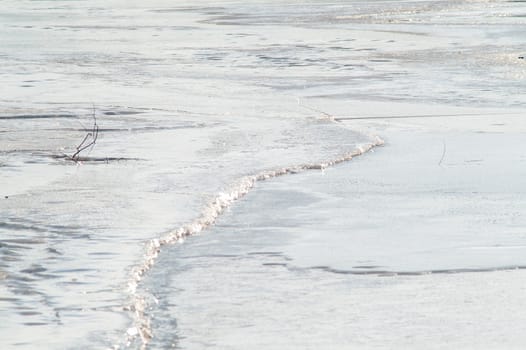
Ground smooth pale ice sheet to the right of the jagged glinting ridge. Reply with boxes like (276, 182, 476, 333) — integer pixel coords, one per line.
(145, 104, 526, 349)
